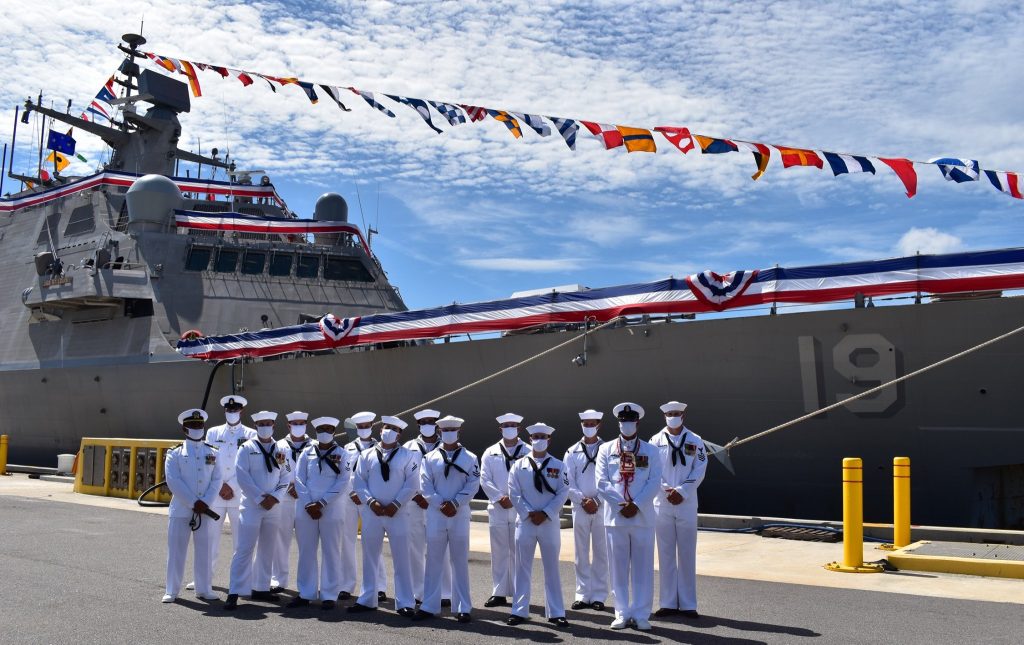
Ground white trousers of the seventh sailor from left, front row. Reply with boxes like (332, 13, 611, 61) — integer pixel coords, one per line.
(356, 509, 416, 609)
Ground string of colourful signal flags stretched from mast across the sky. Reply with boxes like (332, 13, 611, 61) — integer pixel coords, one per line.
(134, 52, 1024, 200)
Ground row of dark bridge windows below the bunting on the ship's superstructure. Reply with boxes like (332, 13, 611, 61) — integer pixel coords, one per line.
(185, 247, 374, 283)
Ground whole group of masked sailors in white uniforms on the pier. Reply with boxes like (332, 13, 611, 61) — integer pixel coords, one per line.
(163, 395, 708, 631)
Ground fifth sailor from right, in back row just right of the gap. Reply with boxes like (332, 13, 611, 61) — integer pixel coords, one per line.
(480, 413, 529, 607)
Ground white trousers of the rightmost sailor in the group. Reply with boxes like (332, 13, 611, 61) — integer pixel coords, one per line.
(655, 503, 697, 610)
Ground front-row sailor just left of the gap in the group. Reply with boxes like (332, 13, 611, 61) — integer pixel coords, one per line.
(413, 416, 480, 622)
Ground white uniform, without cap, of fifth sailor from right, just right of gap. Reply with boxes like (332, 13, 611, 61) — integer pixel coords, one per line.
(480, 439, 529, 596)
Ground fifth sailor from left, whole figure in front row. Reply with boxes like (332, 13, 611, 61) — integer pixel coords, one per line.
(288, 417, 351, 609)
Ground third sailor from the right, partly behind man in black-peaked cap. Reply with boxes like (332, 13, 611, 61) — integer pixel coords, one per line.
(562, 410, 608, 611)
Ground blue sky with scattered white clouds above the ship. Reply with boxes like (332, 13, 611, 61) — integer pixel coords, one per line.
(0, 0, 1024, 308)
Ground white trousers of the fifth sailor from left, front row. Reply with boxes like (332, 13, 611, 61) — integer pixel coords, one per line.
(295, 509, 342, 600)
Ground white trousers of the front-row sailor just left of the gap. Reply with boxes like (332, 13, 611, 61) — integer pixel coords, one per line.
(420, 516, 473, 613)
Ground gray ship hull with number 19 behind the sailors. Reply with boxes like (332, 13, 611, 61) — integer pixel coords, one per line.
(0, 298, 1024, 528)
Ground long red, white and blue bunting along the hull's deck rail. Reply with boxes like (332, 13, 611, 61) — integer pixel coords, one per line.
(177, 249, 1024, 359)
